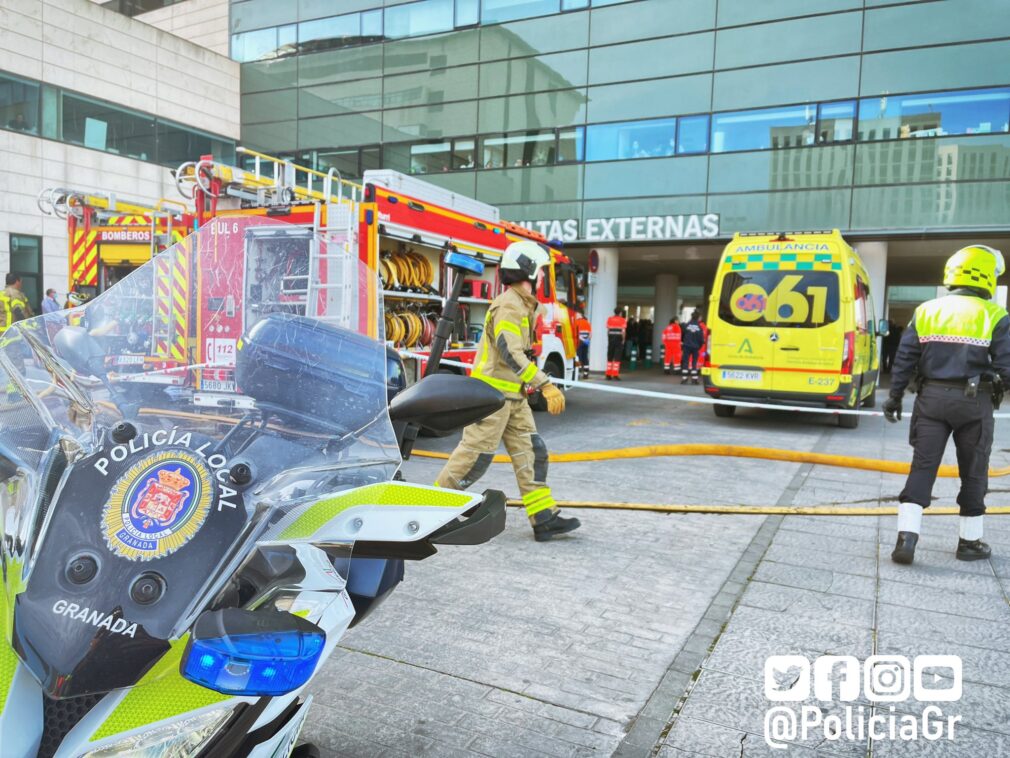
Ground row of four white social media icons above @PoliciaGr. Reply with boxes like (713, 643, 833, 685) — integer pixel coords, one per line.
(765, 655, 963, 702)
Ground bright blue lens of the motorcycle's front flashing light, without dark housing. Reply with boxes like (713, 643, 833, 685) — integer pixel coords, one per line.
(182, 631, 326, 696)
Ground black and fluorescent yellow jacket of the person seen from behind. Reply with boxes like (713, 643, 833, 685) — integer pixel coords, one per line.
(891, 289, 1010, 397)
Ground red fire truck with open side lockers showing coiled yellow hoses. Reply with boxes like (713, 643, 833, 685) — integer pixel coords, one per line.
(176, 149, 585, 405)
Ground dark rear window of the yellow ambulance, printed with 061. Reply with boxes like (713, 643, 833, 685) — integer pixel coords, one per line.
(719, 274, 838, 328)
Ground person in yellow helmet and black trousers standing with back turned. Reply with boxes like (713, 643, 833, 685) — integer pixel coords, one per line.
(884, 245, 1010, 564)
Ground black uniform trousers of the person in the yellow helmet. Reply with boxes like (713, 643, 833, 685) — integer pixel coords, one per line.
(898, 381, 995, 516)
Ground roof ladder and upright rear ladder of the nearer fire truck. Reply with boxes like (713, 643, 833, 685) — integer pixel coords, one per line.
(176, 148, 363, 325)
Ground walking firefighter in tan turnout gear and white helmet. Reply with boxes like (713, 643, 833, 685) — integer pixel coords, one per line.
(435, 241, 580, 542)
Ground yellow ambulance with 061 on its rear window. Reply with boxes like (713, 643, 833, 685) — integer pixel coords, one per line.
(702, 229, 879, 429)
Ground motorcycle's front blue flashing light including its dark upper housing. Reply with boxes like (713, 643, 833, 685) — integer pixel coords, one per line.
(182, 608, 326, 696)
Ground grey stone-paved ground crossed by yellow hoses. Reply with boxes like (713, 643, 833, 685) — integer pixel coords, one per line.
(303, 376, 1010, 758)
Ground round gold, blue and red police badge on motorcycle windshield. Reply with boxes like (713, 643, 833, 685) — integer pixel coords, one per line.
(102, 450, 214, 561)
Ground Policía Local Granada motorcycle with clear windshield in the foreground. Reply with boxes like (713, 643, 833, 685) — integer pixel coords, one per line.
(0, 218, 505, 758)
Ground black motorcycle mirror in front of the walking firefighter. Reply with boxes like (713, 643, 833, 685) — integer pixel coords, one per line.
(389, 374, 505, 434)
